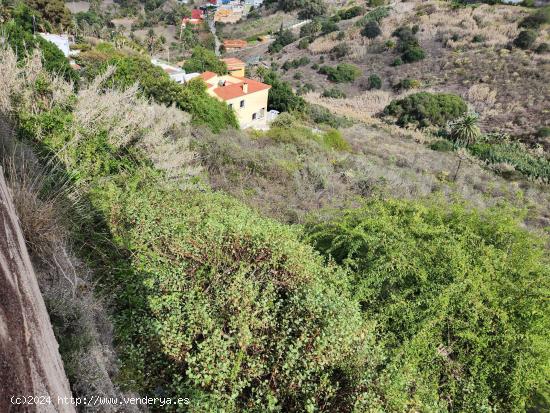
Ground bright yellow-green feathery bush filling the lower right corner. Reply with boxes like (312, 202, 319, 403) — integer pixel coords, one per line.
(306, 200, 550, 412)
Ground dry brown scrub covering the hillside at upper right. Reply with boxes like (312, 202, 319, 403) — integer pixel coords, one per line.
(275, 1, 550, 146)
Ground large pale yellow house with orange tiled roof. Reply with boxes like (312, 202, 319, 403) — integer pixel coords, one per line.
(200, 72, 271, 129)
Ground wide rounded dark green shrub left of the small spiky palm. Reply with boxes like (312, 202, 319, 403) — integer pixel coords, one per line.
(384, 92, 467, 126)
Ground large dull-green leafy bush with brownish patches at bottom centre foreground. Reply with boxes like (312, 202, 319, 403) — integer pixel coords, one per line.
(112, 184, 376, 411)
